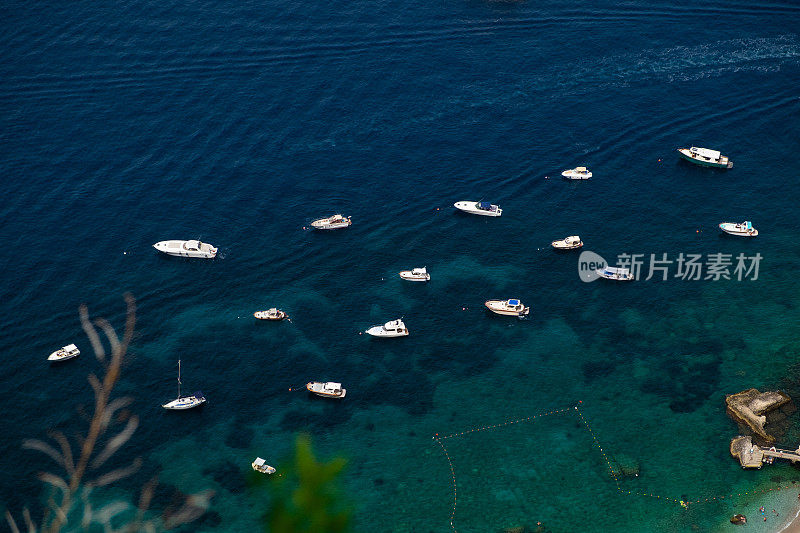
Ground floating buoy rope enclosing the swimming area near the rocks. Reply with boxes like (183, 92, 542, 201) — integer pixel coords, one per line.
(433, 401, 800, 533)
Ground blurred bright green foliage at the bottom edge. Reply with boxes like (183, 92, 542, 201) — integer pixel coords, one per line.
(263, 435, 353, 533)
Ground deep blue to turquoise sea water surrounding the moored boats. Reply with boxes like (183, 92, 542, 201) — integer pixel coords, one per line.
(0, 1, 800, 531)
